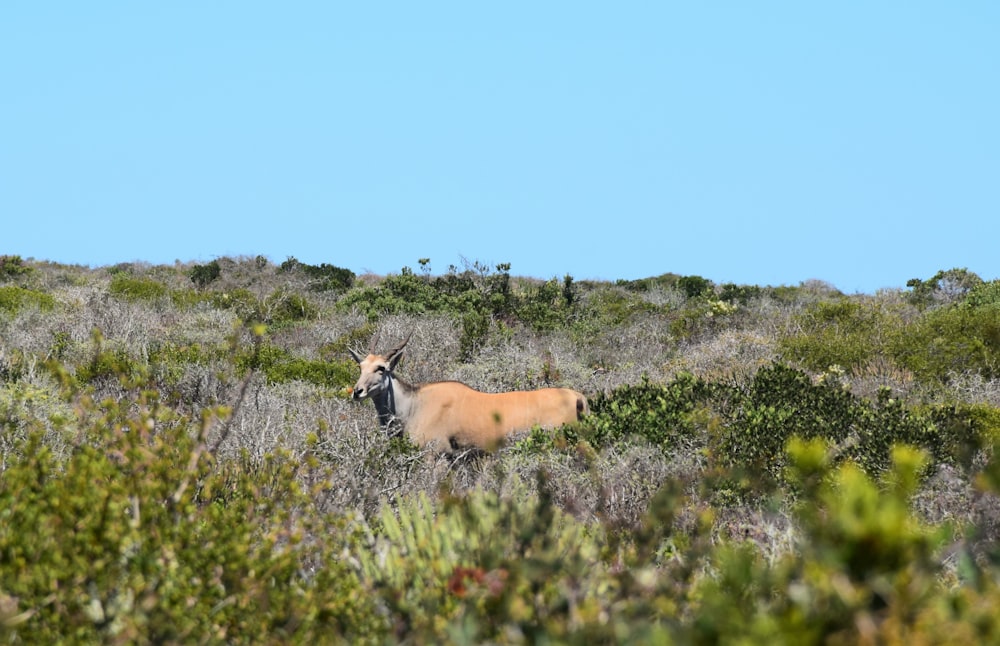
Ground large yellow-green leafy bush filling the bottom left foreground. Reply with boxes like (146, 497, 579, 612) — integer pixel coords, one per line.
(0, 364, 386, 643)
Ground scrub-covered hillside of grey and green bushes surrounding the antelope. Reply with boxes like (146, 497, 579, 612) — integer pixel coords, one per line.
(0, 256, 1000, 644)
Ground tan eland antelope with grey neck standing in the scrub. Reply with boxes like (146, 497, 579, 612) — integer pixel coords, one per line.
(348, 332, 589, 452)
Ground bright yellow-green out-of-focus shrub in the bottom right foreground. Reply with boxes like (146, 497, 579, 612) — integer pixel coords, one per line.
(681, 441, 952, 644)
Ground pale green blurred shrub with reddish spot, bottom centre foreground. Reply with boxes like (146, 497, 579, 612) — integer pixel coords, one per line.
(356, 478, 665, 643)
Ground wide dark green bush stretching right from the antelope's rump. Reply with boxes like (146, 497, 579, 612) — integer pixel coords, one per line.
(532, 364, 984, 486)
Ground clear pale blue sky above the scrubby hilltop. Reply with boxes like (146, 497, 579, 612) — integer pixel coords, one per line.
(0, 0, 1000, 292)
